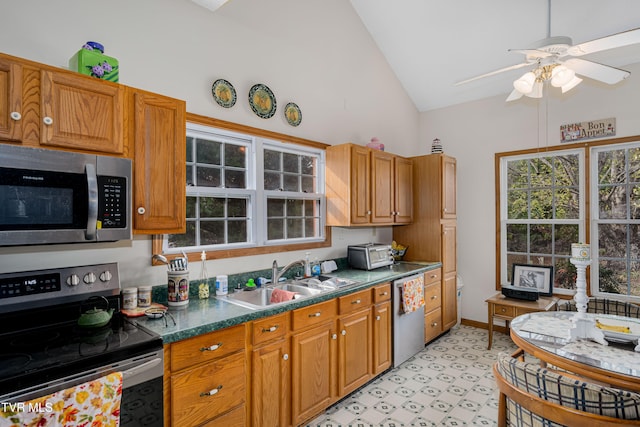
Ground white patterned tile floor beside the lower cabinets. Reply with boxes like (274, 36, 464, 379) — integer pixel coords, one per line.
(308, 326, 516, 427)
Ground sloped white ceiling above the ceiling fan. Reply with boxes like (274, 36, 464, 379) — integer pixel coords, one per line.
(351, 0, 640, 112)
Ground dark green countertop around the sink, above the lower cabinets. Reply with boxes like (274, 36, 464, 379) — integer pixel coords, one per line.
(135, 262, 442, 344)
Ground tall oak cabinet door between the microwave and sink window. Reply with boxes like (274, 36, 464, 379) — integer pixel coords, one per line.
(127, 88, 186, 234)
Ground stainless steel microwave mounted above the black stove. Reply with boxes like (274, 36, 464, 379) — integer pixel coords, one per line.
(0, 144, 131, 246)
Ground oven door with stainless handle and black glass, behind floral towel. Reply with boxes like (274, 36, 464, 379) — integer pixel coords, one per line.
(0, 349, 164, 427)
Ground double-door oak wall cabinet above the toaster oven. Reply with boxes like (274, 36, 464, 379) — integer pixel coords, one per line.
(326, 144, 413, 226)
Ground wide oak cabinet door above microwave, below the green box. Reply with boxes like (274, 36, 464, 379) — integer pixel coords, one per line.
(40, 69, 124, 154)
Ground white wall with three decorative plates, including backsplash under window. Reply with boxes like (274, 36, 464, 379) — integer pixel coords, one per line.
(0, 0, 419, 287)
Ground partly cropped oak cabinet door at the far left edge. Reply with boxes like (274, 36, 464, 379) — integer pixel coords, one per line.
(0, 58, 22, 141)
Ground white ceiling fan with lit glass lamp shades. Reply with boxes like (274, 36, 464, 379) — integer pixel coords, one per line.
(456, 4, 640, 101)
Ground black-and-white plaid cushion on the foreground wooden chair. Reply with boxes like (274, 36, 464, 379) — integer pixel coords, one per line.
(497, 353, 640, 426)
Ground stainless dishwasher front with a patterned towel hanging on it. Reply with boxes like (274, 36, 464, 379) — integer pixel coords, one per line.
(393, 274, 424, 367)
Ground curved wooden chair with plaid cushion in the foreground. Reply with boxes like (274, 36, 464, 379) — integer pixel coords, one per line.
(493, 353, 640, 427)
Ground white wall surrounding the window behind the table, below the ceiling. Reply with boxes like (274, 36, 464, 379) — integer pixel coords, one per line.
(420, 69, 640, 322)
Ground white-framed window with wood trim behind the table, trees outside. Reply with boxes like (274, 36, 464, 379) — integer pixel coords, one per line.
(496, 138, 640, 300)
